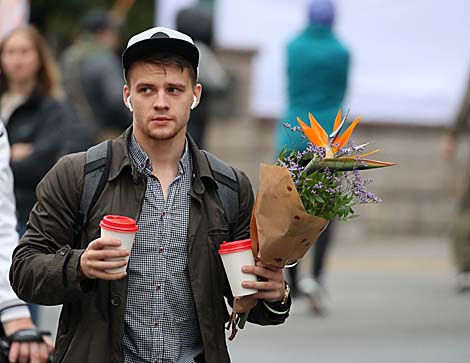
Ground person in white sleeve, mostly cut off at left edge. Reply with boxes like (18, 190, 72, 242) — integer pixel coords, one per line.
(0, 122, 51, 363)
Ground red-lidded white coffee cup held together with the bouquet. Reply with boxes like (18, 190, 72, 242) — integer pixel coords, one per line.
(219, 239, 258, 297)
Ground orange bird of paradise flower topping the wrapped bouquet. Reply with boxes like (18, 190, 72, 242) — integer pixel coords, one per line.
(297, 110, 396, 174)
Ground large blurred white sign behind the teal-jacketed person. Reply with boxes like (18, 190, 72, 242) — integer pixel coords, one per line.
(215, 0, 470, 124)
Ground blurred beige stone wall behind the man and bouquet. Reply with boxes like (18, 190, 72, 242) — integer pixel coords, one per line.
(208, 49, 470, 240)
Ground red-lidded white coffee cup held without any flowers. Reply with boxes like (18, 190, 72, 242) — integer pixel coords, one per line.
(100, 215, 138, 273)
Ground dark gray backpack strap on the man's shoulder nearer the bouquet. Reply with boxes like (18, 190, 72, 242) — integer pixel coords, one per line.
(202, 150, 240, 239)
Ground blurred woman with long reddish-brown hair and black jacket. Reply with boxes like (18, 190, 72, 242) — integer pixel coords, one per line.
(0, 26, 79, 322)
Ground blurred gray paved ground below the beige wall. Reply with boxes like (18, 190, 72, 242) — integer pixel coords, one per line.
(39, 235, 470, 363)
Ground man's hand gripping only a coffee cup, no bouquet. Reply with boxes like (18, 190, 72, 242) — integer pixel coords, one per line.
(79, 238, 130, 280)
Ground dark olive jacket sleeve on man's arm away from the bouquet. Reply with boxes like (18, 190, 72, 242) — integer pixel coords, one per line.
(10, 153, 85, 305)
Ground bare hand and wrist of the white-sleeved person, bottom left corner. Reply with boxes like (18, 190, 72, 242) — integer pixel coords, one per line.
(3, 318, 54, 363)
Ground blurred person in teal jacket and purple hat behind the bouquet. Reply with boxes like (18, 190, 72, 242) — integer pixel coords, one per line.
(274, 0, 350, 314)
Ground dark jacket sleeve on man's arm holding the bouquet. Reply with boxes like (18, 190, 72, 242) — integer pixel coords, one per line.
(226, 172, 291, 325)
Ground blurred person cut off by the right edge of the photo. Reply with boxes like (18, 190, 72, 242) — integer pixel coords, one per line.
(444, 70, 470, 292)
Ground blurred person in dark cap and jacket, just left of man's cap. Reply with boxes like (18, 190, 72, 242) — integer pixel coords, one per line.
(61, 8, 132, 141)
